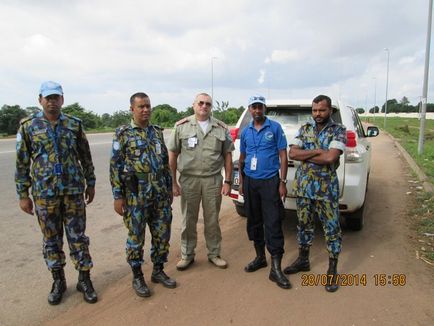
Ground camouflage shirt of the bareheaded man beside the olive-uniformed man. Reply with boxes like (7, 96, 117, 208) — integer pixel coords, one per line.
(110, 120, 172, 199)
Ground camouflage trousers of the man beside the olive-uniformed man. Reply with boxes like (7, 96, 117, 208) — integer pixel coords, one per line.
(124, 183, 172, 267)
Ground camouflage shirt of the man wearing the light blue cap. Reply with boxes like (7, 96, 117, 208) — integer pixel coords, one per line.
(15, 112, 95, 199)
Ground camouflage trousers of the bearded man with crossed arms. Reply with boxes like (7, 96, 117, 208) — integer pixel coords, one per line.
(296, 197, 342, 258)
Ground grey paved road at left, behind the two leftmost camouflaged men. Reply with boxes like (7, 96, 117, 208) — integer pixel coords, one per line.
(0, 131, 195, 325)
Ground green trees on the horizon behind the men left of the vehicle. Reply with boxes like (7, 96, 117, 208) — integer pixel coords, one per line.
(0, 101, 245, 135)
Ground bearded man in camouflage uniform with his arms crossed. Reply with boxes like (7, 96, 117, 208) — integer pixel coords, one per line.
(284, 95, 346, 292)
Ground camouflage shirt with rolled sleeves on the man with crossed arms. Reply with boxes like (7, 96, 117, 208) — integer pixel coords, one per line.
(289, 118, 347, 201)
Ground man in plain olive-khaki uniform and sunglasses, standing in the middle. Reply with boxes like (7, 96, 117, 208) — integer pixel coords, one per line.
(168, 93, 234, 270)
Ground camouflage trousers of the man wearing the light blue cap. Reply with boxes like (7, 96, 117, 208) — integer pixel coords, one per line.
(34, 194, 93, 271)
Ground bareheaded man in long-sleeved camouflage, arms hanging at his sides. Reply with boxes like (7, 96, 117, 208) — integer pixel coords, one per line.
(110, 93, 176, 297)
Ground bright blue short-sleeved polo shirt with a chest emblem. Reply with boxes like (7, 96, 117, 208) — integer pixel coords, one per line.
(240, 118, 287, 179)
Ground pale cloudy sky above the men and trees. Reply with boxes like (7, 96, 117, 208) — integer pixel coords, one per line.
(0, 0, 434, 114)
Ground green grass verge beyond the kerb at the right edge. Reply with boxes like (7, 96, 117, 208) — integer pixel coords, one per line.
(362, 117, 434, 184)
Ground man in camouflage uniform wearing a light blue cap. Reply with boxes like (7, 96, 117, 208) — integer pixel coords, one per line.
(15, 81, 97, 305)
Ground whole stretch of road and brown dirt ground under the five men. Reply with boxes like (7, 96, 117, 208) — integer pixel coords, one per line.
(0, 135, 434, 326)
